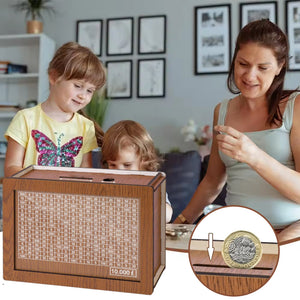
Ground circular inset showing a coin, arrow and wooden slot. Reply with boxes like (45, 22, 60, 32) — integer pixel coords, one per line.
(188, 206, 279, 296)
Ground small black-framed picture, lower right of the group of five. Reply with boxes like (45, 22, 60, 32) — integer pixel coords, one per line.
(137, 58, 166, 98)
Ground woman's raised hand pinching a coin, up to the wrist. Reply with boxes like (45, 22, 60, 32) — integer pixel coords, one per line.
(214, 125, 260, 166)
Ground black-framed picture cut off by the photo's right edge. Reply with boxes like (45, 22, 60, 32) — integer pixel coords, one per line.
(285, 1, 300, 71)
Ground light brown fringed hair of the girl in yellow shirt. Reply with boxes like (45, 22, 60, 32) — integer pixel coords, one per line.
(48, 42, 105, 89)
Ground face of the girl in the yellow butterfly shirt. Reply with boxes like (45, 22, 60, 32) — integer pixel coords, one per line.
(49, 76, 96, 113)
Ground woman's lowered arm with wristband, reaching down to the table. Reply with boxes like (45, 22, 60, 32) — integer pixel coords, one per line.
(174, 105, 226, 223)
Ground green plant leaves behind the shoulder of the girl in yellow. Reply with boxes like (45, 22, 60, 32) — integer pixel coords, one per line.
(84, 92, 109, 127)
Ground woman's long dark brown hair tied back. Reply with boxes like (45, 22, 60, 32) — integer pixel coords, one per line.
(227, 19, 295, 125)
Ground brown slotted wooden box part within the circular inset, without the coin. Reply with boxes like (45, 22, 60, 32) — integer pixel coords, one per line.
(189, 241, 279, 296)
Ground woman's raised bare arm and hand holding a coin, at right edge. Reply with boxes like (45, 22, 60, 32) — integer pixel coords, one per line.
(215, 96, 300, 203)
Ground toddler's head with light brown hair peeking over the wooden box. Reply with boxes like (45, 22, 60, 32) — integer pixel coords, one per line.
(102, 120, 159, 171)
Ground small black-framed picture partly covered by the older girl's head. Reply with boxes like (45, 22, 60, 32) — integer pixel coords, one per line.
(76, 20, 102, 56)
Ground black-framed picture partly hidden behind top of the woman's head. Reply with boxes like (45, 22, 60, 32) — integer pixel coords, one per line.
(240, 1, 277, 28)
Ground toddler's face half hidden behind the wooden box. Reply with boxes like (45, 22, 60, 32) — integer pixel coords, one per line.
(107, 146, 142, 171)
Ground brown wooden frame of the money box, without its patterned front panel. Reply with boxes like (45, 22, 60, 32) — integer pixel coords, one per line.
(3, 166, 166, 294)
